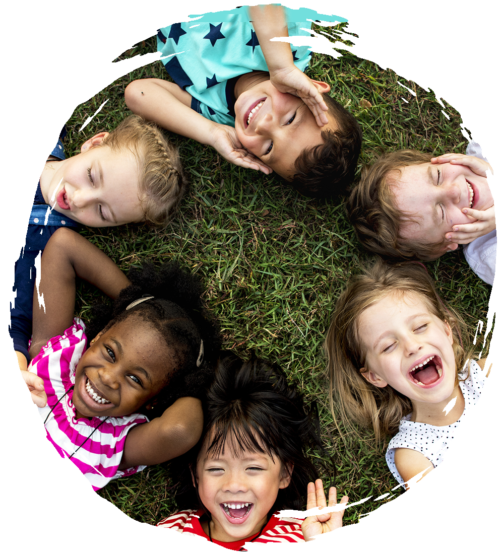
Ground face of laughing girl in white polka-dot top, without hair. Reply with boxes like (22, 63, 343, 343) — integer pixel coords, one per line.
(357, 292, 457, 407)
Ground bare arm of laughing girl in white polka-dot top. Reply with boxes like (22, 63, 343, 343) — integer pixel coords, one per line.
(395, 448, 440, 491)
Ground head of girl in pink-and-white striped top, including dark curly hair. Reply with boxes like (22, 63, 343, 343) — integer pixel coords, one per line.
(73, 263, 220, 417)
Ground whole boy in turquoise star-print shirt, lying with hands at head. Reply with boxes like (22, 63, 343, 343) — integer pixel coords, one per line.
(125, 4, 362, 197)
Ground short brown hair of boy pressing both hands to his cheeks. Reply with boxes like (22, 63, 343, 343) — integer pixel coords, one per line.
(347, 150, 447, 261)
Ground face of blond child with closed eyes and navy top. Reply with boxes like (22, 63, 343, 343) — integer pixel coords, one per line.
(40, 133, 144, 227)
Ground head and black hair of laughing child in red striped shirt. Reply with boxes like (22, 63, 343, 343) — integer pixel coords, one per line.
(175, 355, 320, 541)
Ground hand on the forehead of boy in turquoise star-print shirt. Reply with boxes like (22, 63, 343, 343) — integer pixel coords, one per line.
(270, 64, 329, 127)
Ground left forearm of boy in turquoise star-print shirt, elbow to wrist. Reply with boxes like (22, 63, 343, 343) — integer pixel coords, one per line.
(124, 79, 218, 145)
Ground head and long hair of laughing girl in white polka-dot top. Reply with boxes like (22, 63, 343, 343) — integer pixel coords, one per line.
(324, 261, 472, 439)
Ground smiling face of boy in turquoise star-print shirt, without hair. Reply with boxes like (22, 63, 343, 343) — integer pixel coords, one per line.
(235, 79, 338, 179)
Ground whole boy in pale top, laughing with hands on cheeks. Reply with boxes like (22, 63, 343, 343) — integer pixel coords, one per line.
(347, 141, 504, 285)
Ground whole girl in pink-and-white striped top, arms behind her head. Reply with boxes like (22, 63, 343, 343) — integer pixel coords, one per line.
(20, 228, 221, 536)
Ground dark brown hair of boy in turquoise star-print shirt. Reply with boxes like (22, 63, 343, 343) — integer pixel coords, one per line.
(289, 93, 362, 198)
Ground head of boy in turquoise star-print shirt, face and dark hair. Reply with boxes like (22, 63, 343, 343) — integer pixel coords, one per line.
(235, 79, 362, 198)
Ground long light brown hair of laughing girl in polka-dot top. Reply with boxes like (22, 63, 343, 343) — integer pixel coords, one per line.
(323, 260, 474, 442)
